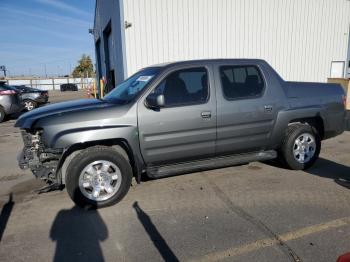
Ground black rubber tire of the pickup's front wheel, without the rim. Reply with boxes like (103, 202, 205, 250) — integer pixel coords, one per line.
(66, 146, 132, 209)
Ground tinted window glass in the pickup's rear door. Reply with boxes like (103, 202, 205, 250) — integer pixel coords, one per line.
(220, 65, 264, 100)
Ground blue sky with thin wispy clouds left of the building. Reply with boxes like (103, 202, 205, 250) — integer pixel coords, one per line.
(0, 0, 95, 76)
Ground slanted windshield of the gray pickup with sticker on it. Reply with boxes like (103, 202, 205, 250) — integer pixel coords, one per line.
(103, 67, 160, 104)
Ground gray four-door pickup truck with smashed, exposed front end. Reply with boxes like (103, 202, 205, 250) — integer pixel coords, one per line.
(15, 59, 345, 207)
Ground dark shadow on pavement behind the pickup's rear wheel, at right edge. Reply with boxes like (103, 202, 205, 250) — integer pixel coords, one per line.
(305, 158, 350, 189)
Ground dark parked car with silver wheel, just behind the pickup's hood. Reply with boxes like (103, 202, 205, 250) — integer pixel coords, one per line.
(13, 85, 49, 111)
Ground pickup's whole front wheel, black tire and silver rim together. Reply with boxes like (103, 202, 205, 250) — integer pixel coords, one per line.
(66, 146, 132, 208)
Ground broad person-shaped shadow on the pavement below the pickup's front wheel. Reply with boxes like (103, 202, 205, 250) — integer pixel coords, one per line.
(50, 206, 108, 262)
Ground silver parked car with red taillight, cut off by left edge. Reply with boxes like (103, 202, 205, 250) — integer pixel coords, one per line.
(0, 82, 23, 123)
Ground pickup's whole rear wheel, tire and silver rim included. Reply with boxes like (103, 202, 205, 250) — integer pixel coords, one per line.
(281, 124, 321, 170)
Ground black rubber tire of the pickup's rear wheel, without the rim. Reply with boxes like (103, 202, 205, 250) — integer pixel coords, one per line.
(279, 124, 321, 170)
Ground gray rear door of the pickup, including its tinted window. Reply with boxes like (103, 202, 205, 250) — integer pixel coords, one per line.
(215, 64, 277, 155)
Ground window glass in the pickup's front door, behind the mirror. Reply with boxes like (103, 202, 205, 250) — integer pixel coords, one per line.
(150, 67, 209, 107)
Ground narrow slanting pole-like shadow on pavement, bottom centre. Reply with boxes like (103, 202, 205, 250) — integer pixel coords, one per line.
(133, 201, 179, 261)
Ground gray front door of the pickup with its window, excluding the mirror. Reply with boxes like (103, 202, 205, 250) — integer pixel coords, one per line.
(138, 66, 216, 165)
